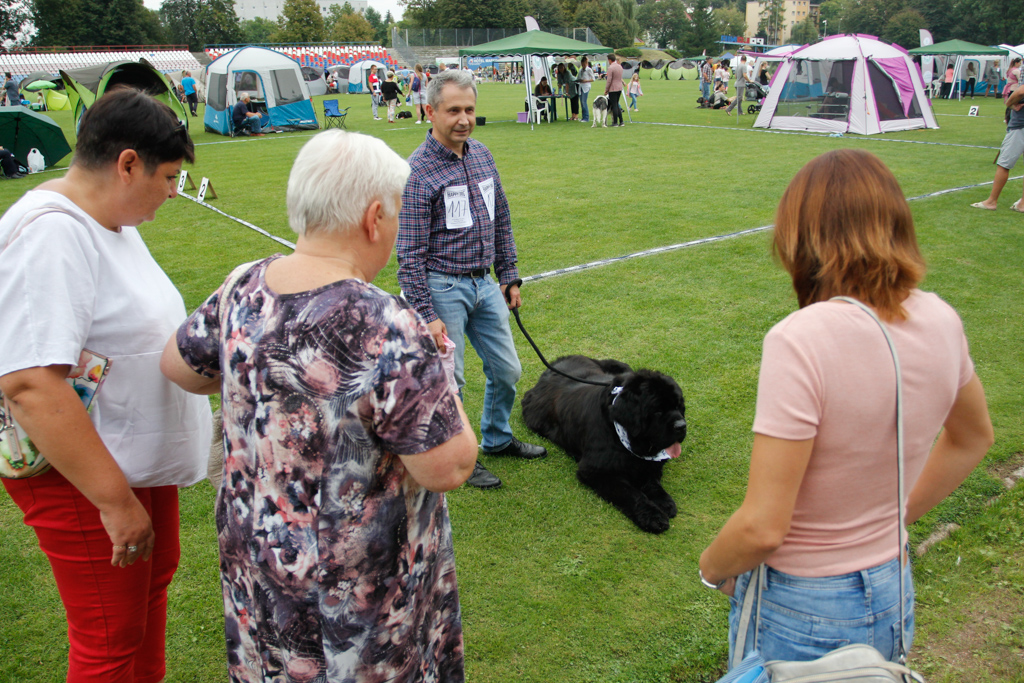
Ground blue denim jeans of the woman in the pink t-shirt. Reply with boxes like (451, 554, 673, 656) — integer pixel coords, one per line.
(729, 559, 913, 663)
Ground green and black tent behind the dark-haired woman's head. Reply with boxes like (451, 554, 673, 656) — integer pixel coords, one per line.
(60, 59, 188, 128)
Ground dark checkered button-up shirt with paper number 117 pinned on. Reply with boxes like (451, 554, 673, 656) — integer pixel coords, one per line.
(395, 131, 519, 323)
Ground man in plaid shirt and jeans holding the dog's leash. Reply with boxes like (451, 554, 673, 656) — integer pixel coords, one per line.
(395, 70, 548, 488)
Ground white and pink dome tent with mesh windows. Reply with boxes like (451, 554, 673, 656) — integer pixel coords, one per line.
(754, 35, 939, 135)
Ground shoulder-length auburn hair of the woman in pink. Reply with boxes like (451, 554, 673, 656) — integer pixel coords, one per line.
(772, 150, 925, 321)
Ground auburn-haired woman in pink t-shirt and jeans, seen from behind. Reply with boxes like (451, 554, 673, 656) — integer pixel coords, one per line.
(700, 150, 992, 661)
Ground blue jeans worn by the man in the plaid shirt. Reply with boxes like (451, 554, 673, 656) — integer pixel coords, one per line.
(427, 270, 522, 452)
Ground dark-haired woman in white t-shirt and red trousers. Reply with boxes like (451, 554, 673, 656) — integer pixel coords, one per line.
(0, 89, 212, 683)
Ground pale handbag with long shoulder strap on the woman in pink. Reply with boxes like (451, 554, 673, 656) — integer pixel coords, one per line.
(722, 297, 925, 683)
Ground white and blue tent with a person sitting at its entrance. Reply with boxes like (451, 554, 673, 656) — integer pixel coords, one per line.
(203, 47, 319, 135)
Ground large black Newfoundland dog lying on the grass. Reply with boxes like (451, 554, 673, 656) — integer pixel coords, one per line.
(522, 355, 686, 533)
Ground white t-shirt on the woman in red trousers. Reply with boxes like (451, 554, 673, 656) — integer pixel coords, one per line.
(0, 190, 212, 486)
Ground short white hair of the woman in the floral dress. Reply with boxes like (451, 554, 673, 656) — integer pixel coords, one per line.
(288, 130, 410, 236)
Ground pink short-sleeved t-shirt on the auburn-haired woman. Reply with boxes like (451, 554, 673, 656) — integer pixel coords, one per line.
(754, 290, 974, 577)
